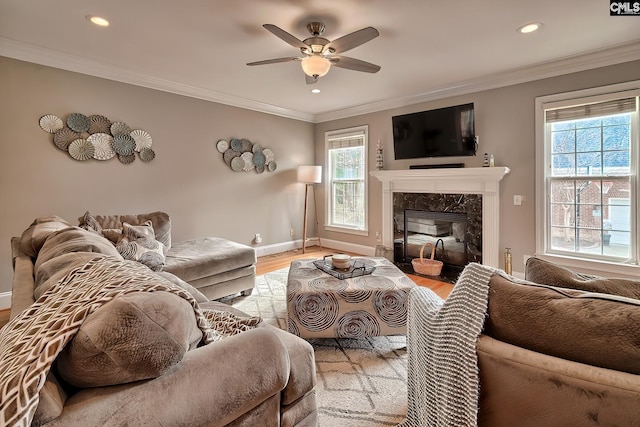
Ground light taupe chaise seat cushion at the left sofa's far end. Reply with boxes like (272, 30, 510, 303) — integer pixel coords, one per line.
(164, 237, 256, 282)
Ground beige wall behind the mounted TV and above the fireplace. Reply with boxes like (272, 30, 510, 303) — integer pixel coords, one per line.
(315, 61, 640, 272)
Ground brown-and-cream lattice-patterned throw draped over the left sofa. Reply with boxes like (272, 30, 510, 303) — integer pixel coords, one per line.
(0, 257, 260, 426)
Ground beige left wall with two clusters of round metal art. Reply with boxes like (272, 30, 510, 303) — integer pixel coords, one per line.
(0, 57, 315, 293)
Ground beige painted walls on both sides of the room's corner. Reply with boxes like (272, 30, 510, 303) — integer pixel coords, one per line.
(0, 57, 640, 293)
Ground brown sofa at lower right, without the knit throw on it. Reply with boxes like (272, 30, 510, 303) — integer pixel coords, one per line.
(477, 258, 640, 427)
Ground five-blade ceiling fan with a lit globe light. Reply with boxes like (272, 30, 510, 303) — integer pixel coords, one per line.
(247, 22, 380, 84)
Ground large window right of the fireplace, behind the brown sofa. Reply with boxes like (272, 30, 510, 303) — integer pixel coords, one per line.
(536, 82, 640, 274)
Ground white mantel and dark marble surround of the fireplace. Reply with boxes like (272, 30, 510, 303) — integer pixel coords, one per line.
(370, 167, 510, 267)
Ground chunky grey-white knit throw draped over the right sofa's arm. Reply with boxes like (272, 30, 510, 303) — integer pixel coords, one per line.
(399, 264, 495, 427)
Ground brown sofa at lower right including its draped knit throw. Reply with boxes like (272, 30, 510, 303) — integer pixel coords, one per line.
(402, 258, 640, 427)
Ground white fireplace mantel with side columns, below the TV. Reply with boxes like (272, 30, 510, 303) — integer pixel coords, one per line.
(370, 166, 510, 267)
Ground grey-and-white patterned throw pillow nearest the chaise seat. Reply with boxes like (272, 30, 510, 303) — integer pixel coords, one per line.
(116, 221, 165, 271)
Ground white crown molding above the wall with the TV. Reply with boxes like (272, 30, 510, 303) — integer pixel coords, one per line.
(314, 40, 640, 123)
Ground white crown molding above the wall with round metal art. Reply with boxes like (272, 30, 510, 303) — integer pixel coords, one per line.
(0, 37, 313, 122)
